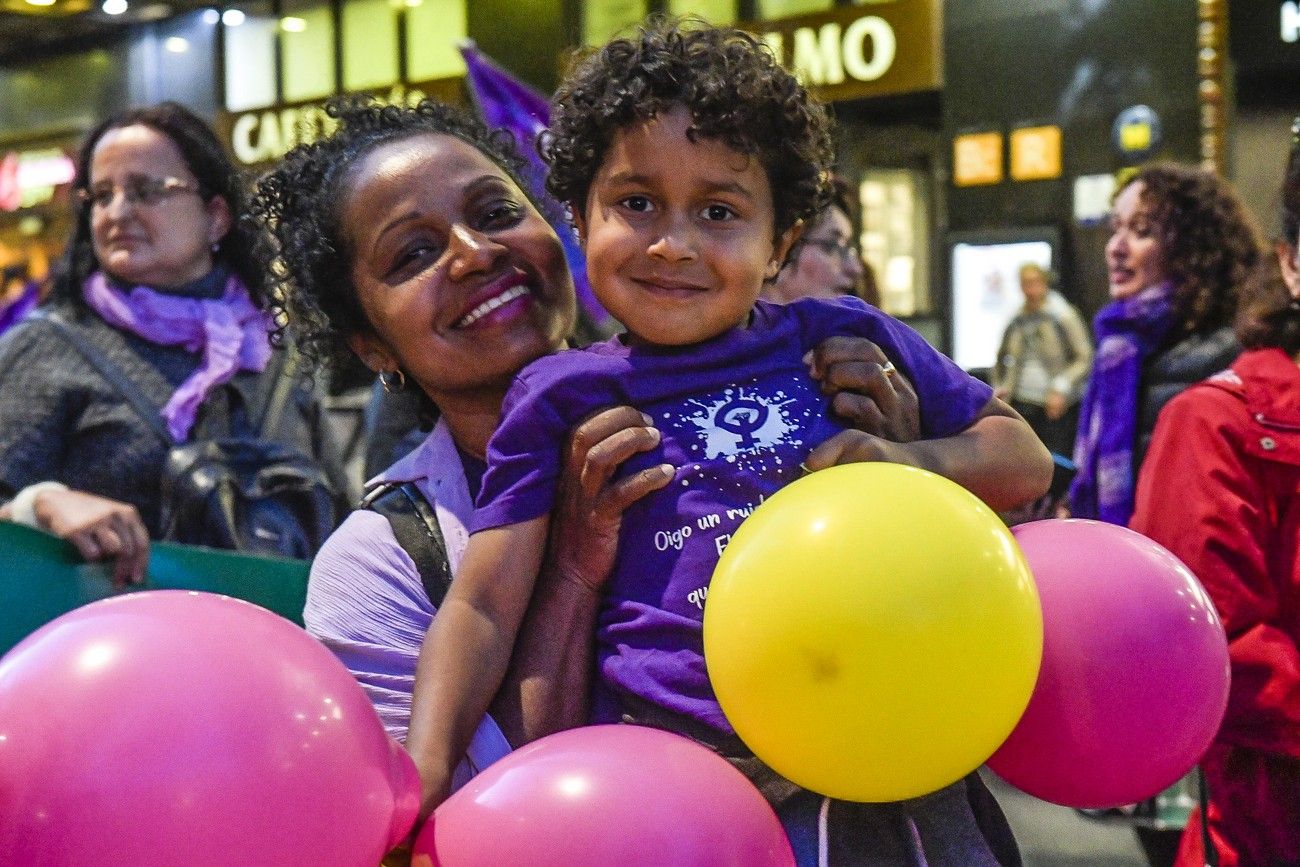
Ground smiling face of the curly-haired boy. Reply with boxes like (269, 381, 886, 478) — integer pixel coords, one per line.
(575, 107, 798, 346)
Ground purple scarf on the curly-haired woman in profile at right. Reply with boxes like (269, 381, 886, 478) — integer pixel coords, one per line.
(1070, 283, 1174, 525)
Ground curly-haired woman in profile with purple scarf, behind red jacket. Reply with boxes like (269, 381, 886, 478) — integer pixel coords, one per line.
(1070, 164, 1261, 524)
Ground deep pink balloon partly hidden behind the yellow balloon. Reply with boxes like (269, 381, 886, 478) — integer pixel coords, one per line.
(988, 520, 1229, 807)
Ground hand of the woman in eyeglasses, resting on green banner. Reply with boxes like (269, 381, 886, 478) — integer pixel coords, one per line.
(33, 490, 150, 585)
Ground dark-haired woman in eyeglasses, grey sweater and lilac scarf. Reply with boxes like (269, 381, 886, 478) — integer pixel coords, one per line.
(0, 103, 340, 582)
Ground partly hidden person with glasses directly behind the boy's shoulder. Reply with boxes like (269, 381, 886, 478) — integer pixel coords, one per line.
(762, 175, 880, 307)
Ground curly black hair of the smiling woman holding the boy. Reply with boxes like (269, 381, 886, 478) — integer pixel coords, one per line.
(250, 96, 536, 368)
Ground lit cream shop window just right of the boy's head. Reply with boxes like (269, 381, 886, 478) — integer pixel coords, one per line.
(858, 169, 932, 316)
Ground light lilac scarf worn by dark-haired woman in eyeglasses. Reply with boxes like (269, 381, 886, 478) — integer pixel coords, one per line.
(82, 272, 272, 442)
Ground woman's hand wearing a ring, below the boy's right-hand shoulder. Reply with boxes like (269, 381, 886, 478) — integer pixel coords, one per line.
(803, 337, 920, 442)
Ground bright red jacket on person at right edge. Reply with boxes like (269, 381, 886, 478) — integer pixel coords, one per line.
(1130, 350, 1300, 867)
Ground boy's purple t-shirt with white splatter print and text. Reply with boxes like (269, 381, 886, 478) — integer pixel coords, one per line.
(471, 298, 992, 732)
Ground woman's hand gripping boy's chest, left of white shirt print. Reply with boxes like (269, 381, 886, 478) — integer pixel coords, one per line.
(543, 407, 673, 594)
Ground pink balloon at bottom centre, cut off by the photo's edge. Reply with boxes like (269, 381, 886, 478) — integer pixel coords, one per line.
(421, 725, 794, 867)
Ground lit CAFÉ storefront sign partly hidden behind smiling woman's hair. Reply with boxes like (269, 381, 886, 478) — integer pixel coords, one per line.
(218, 78, 462, 165)
